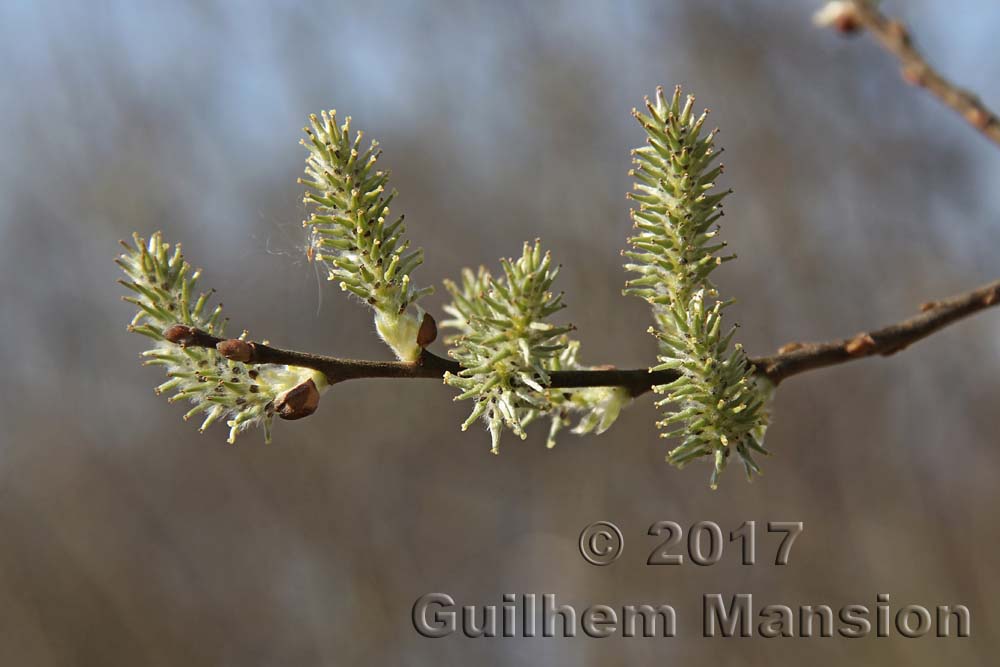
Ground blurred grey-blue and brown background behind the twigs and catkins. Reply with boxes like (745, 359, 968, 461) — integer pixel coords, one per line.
(0, 0, 1000, 666)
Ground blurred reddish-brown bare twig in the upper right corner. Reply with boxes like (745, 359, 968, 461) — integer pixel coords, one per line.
(852, 0, 1000, 145)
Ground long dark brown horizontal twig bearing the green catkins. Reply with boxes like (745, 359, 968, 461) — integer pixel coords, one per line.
(164, 280, 1000, 397)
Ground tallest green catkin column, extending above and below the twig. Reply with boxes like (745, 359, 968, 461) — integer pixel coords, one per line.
(623, 87, 773, 488)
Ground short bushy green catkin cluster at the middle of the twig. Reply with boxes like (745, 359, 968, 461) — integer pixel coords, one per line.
(441, 241, 629, 454)
